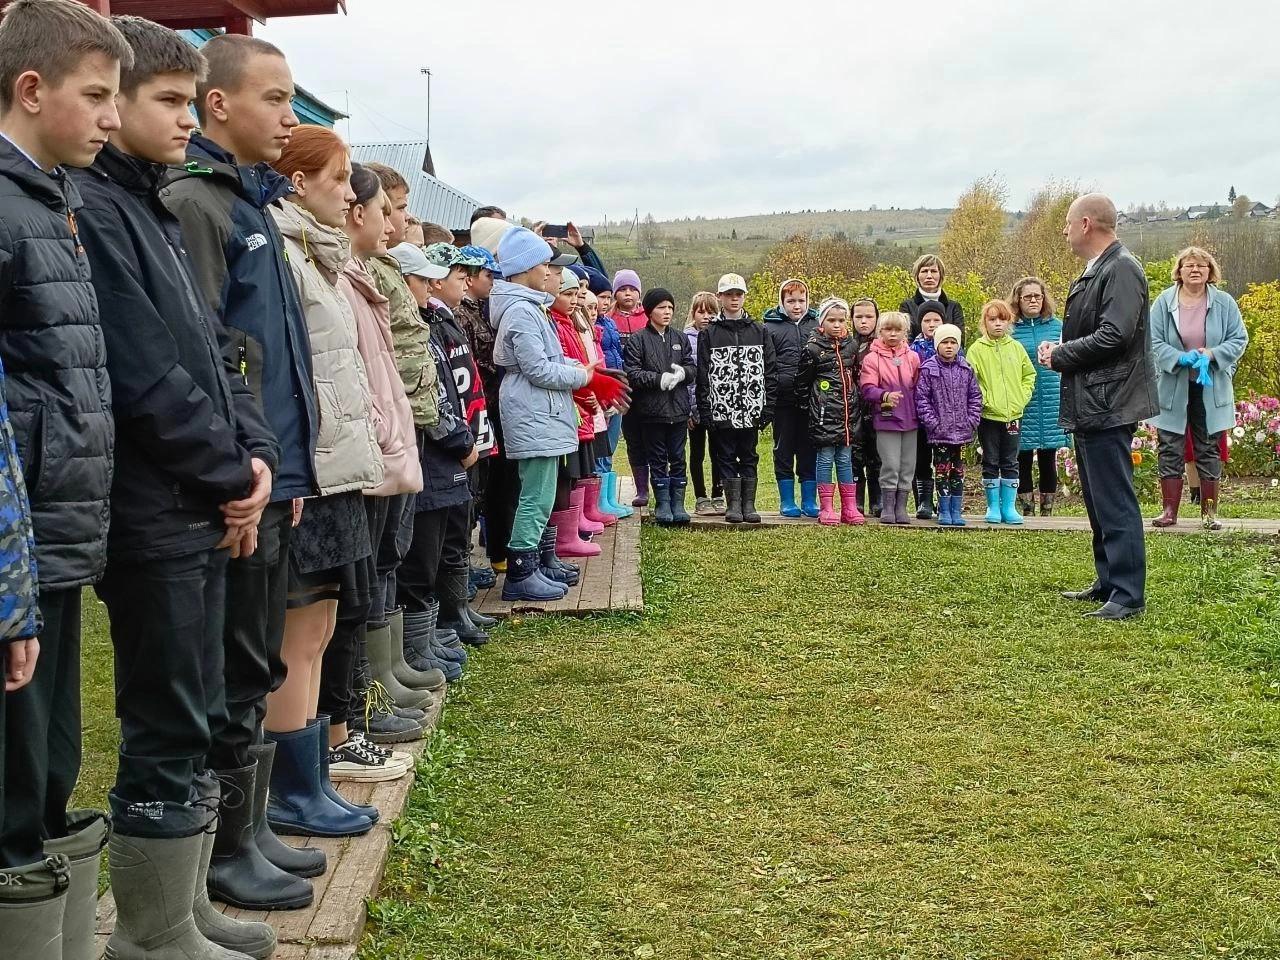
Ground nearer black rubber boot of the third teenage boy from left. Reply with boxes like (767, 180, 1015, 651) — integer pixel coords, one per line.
(209, 763, 314, 916)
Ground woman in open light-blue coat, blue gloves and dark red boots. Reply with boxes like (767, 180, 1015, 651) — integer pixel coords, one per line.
(1151, 247, 1249, 530)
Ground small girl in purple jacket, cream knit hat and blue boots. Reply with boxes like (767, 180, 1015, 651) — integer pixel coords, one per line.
(915, 324, 982, 526)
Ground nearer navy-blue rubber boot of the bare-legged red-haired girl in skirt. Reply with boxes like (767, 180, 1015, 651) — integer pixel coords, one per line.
(265, 724, 374, 837)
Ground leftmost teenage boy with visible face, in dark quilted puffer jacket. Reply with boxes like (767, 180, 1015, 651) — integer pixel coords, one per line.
(0, 0, 132, 956)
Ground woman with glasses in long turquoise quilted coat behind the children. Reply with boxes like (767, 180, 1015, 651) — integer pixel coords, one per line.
(1009, 276, 1069, 517)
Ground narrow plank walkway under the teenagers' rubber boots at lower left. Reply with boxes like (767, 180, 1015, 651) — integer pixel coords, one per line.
(97, 740, 426, 960)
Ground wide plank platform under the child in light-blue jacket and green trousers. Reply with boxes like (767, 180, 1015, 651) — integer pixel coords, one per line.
(471, 511, 644, 617)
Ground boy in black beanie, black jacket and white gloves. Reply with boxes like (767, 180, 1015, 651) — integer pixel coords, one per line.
(622, 289, 696, 526)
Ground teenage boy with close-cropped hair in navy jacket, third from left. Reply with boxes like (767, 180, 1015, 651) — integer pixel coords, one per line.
(163, 33, 325, 910)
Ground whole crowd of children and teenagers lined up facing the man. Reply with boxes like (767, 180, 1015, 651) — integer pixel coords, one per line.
(0, 0, 1243, 960)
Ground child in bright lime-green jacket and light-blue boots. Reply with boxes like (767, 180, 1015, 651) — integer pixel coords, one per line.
(966, 300, 1036, 524)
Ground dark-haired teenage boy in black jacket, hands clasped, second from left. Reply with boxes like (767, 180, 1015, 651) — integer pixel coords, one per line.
(73, 17, 286, 956)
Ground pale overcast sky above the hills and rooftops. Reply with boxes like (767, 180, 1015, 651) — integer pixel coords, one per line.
(257, 0, 1280, 223)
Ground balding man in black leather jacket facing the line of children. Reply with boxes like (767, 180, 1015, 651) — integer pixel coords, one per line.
(1039, 193, 1156, 620)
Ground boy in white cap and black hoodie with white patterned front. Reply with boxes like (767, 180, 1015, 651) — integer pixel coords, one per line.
(698, 274, 778, 524)
